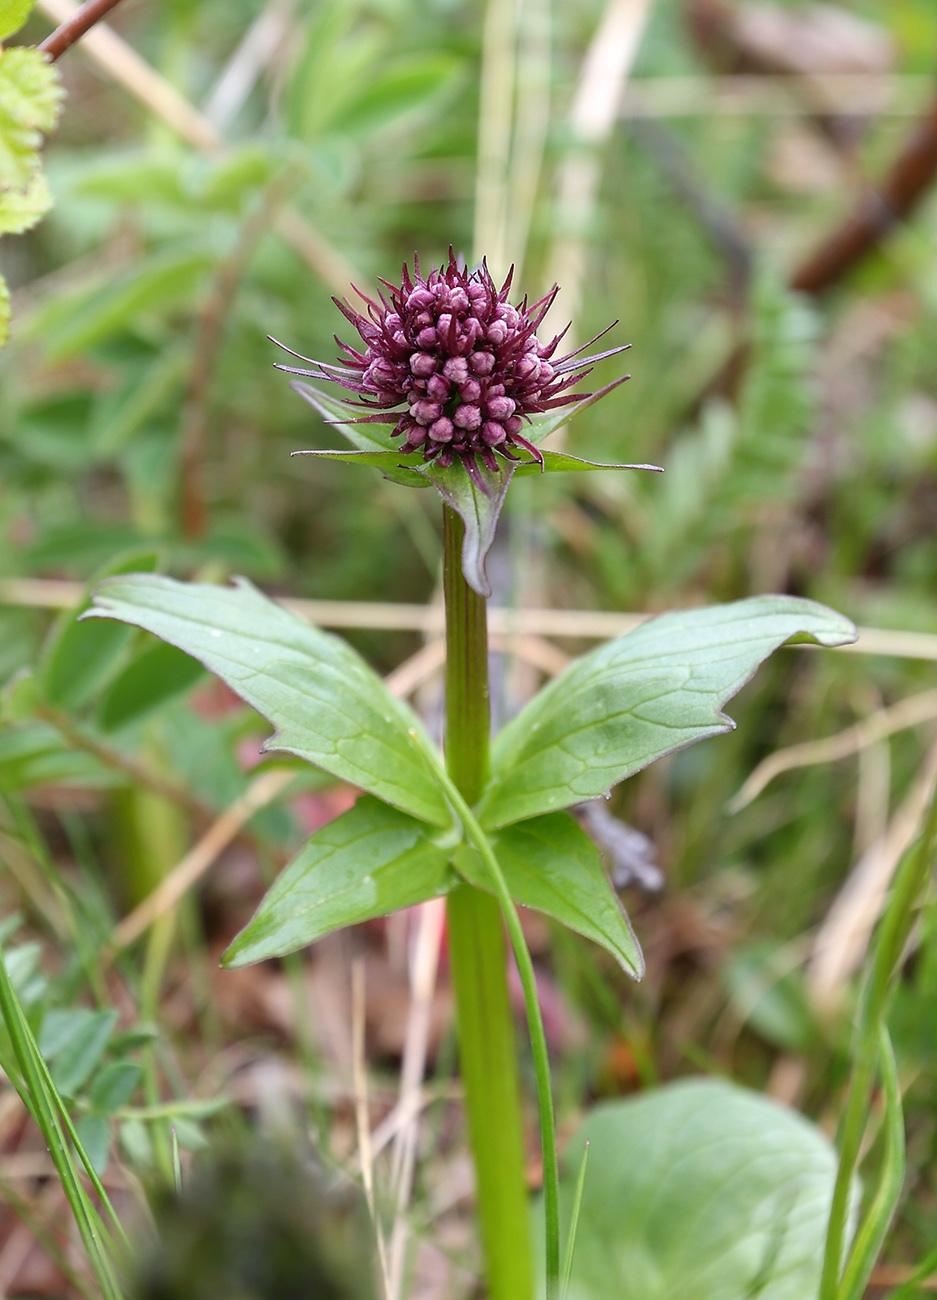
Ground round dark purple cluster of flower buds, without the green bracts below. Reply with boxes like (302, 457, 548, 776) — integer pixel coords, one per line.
(270, 248, 624, 490)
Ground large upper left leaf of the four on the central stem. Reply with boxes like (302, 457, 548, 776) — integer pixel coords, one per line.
(86, 573, 451, 826)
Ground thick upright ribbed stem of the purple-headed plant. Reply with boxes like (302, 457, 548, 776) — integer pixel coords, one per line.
(443, 506, 533, 1300)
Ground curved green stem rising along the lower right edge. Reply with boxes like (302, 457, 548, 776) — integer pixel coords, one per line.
(820, 774, 937, 1300)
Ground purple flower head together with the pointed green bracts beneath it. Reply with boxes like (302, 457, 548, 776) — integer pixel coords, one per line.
(272, 248, 659, 595)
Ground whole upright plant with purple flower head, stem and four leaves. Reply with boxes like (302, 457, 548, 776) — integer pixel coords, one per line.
(90, 256, 855, 1300)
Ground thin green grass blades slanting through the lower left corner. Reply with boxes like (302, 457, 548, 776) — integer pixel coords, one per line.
(0, 952, 122, 1300)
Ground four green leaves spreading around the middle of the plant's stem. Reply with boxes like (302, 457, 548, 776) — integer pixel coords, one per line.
(85, 574, 855, 978)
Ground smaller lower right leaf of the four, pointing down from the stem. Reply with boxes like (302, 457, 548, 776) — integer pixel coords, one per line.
(455, 813, 645, 979)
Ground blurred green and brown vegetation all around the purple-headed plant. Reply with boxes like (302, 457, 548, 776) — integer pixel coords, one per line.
(0, 0, 937, 1297)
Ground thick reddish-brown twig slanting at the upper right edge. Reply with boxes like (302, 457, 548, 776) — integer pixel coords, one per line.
(790, 81, 937, 294)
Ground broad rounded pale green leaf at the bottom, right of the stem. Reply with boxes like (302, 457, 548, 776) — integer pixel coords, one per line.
(539, 1079, 836, 1300)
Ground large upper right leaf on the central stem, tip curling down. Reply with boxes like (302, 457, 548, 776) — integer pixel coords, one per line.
(480, 595, 856, 827)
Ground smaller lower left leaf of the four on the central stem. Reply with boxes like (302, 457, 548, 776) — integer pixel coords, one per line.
(221, 796, 459, 967)
